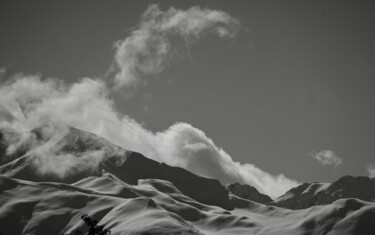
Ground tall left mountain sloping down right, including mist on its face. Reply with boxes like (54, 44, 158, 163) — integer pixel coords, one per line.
(0, 126, 233, 209)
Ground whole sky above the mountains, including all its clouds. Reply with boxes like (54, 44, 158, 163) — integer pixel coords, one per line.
(0, 0, 375, 196)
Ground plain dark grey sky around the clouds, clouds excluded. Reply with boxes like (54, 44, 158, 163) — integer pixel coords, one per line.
(0, 0, 375, 184)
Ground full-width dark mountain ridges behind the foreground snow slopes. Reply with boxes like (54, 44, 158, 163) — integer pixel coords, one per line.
(0, 123, 375, 209)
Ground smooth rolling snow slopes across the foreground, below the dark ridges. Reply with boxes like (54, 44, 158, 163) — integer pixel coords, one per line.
(0, 173, 375, 235)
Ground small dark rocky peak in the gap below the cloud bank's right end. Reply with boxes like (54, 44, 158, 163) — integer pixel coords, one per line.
(227, 183, 272, 204)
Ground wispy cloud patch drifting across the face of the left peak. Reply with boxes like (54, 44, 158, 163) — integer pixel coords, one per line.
(27, 123, 126, 178)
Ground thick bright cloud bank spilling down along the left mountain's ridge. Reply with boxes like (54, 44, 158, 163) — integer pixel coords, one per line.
(0, 76, 298, 197)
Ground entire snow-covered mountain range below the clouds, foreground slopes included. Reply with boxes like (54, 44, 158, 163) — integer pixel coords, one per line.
(0, 125, 375, 235)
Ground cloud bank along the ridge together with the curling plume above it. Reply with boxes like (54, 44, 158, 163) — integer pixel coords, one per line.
(0, 6, 298, 197)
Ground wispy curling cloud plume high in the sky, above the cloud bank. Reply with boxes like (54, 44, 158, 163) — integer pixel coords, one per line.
(114, 5, 239, 87)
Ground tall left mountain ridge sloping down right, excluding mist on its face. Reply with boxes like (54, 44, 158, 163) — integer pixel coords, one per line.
(0, 126, 233, 209)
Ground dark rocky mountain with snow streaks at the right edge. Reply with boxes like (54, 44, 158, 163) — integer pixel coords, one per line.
(270, 176, 375, 209)
